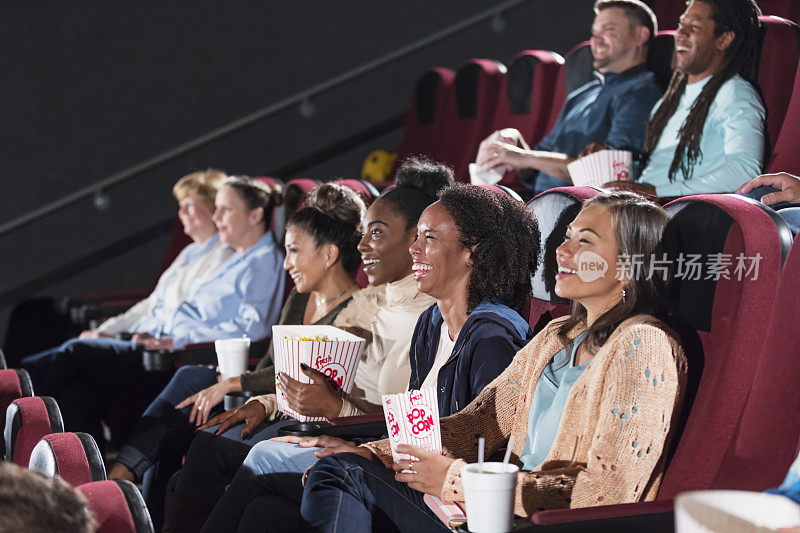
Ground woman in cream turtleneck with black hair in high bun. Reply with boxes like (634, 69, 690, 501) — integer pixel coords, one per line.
(161, 158, 453, 530)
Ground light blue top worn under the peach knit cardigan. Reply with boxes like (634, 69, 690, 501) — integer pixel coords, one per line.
(519, 332, 591, 470)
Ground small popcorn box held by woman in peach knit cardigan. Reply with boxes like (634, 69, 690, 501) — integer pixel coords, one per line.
(382, 388, 442, 461)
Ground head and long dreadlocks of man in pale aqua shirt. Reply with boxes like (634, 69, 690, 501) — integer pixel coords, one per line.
(644, 0, 761, 181)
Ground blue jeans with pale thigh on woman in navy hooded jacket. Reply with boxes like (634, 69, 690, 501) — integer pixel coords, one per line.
(203, 441, 321, 532)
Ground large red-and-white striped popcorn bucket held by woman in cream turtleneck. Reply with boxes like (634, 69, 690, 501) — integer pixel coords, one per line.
(272, 326, 366, 422)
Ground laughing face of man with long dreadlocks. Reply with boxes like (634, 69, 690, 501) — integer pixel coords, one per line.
(674, 1, 735, 83)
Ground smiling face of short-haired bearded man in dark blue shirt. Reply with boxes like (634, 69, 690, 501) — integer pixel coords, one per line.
(589, 7, 649, 73)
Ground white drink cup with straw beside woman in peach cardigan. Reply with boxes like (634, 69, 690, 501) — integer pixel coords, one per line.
(461, 463, 519, 533)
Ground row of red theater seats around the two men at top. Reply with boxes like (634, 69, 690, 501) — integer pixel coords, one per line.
(397, 16, 800, 190)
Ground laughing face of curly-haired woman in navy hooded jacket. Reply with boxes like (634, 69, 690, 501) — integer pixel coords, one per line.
(409, 202, 472, 300)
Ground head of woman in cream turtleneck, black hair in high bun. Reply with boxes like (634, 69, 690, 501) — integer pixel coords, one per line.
(358, 158, 453, 285)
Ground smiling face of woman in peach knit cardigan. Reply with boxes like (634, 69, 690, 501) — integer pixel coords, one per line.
(555, 205, 622, 316)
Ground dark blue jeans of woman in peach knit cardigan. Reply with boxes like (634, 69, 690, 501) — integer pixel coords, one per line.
(302, 453, 450, 532)
